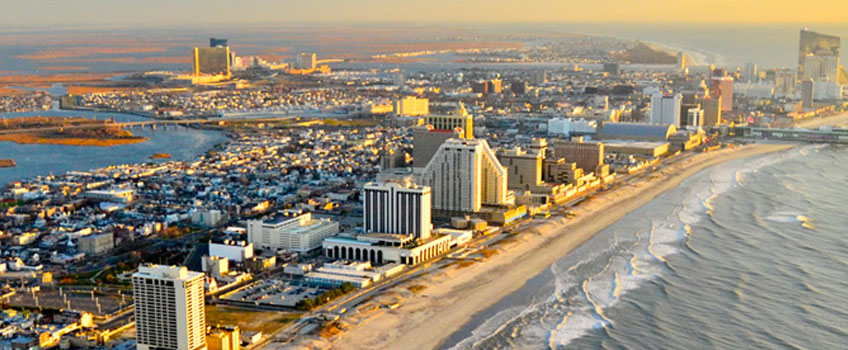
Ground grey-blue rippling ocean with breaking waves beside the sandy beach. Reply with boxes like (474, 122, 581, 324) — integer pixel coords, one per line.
(444, 145, 848, 349)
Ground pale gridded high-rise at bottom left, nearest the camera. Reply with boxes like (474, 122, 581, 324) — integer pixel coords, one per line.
(132, 265, 206, 350)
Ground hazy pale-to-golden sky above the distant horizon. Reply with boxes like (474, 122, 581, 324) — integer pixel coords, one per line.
(0, 0, 848, 28)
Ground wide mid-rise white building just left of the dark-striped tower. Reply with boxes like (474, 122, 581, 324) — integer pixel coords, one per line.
(247, 213, 339, 253)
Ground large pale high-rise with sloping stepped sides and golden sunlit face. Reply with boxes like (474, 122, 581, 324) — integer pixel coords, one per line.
(421, 139, 506, 212)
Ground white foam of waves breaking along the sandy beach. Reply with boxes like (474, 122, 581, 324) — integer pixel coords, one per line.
(453, 146, 802, 349)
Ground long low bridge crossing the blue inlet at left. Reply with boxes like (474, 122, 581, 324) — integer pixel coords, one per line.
(0, 115, 318, 135)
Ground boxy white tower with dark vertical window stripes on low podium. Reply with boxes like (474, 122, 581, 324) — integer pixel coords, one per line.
(363, 182, 433, 240)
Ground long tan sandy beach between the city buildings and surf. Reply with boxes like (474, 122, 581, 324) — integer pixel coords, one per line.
(332, 144, 794, 349)
